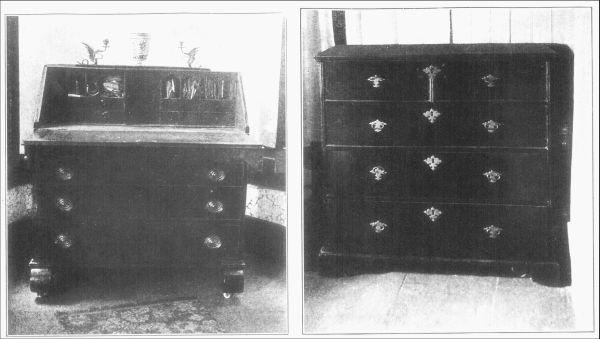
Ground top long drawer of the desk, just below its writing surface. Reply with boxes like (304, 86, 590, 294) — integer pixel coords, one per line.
(36, 148, 244, 186)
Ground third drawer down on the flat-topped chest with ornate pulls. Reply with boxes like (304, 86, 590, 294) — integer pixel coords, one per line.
(327, 149, 548, 205)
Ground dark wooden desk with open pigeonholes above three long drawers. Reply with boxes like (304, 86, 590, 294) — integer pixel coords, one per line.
(25, 65, 262, 302)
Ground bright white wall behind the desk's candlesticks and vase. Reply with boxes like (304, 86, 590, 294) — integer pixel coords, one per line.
(19, 14, 283, 146)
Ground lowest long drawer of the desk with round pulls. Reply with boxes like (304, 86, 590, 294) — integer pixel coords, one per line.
(39, 220, 241, 268)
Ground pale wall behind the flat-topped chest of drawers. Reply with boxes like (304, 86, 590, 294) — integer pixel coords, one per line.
(302, 8, 594, 329)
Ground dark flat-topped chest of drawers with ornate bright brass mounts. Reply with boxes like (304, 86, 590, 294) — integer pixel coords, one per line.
(316, 44, 573, 286)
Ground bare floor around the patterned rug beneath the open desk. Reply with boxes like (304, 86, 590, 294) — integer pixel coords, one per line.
(8, 257, 287, 335)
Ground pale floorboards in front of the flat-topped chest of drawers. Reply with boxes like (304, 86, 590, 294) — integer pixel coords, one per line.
(304, 272, 575, 334)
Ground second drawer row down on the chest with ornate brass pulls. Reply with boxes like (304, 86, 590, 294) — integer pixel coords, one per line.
(325, 102, 548, 147)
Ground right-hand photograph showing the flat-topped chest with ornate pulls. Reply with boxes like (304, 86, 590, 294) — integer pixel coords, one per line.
(301, 6, 597, 334)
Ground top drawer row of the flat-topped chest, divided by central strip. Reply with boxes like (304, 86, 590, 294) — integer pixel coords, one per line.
(323, 57, 548, 101)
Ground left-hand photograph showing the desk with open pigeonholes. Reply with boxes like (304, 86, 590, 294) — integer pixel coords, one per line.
(2, 3, 288, 336)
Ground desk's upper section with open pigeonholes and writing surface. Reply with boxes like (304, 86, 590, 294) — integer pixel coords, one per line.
(25, 65, 277, 147)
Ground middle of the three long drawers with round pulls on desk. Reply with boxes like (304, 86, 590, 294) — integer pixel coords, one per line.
(38, 185, 245, 220)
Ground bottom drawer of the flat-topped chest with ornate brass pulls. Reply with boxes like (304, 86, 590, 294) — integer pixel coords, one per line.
(330, 201, 547, 261)
